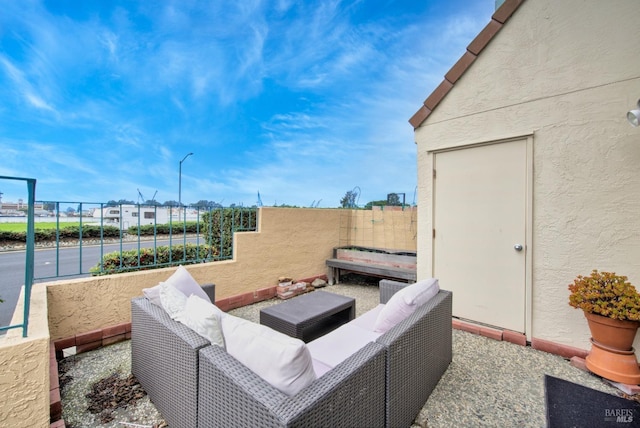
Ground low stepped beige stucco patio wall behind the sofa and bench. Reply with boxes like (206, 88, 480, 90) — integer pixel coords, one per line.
(47, 207, 415, 340)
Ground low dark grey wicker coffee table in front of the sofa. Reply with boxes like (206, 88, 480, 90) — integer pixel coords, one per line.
(260, 291, 356, 342)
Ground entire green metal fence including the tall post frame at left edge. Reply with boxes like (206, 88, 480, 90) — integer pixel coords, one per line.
(0, 196, 257, 335)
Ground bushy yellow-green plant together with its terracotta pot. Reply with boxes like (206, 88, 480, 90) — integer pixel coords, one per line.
(569, 270, 640, 384)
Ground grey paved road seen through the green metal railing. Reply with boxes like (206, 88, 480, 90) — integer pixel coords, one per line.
(0, 237, 204, 335)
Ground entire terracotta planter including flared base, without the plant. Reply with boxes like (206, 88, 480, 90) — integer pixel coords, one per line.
(584, 312, 640, 385)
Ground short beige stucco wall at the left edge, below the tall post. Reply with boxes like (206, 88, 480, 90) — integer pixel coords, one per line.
(0, 284, 49, 428)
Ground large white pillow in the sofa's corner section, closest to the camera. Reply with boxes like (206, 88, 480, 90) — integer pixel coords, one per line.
(222, 314, 316, 395)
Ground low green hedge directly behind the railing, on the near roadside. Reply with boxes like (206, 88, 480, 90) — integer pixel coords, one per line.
(89, 244, 217, 276)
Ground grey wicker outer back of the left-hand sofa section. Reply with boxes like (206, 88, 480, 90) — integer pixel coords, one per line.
(131, 297, 209, 428)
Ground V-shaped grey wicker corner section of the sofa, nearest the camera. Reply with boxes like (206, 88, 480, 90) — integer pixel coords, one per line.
(198, 343, 385, 427)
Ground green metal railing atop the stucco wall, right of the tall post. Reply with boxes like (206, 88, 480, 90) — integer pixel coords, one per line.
(35, 202, 257, 280)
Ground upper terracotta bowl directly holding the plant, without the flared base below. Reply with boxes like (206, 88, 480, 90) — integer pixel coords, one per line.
(584, 312, 640, 351)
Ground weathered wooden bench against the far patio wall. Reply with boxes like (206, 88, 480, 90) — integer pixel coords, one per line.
(326, 247, 416, 284)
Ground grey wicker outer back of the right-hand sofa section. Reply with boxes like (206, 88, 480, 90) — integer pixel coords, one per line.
(377, 290, 453, 427)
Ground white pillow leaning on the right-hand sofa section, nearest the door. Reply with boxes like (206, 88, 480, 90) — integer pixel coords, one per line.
(373, 278, 440, 333)
